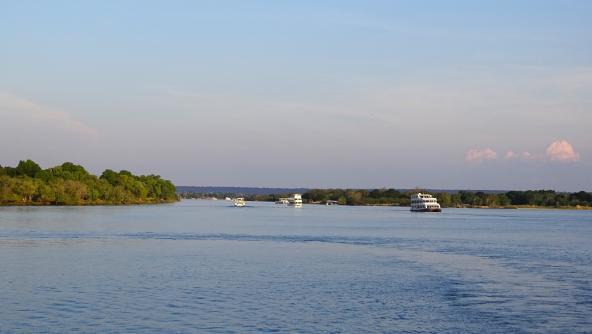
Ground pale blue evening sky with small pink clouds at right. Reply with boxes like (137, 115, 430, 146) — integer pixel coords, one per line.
(0, 1, 592, 190)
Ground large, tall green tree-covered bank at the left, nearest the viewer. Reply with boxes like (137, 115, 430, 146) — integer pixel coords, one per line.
(0, 160, 177, 205)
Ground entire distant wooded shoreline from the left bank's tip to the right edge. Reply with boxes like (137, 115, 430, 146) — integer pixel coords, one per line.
(183, 189, 592, 209)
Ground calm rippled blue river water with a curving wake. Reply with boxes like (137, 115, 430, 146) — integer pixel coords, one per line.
(0, 200, 592, 333)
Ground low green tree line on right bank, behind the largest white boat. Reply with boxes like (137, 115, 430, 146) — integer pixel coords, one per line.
(302, 189, 592, 207)
